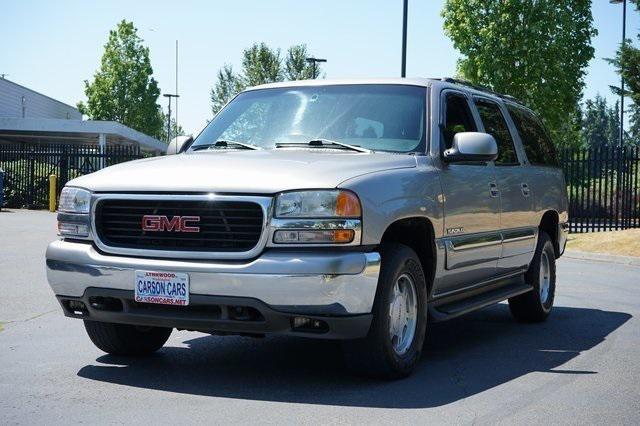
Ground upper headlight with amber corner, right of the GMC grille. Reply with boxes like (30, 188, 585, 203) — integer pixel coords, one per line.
(275, 189, 362, 218)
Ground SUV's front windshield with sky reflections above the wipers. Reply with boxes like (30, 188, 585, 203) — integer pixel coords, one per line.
(191, 84, 426, 152)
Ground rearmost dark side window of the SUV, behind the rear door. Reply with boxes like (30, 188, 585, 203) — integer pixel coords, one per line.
(507, 104, 558, 166)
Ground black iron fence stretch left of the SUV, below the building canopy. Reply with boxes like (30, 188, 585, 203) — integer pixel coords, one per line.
(0, 144, 142, 209)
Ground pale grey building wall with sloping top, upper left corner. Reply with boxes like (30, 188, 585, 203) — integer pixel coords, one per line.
(0, 78, 82, 120)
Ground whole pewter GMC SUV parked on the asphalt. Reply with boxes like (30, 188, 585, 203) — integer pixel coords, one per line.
(46, 79, 568, 378)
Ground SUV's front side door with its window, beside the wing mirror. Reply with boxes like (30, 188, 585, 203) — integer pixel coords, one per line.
(438, 90, 502, 294)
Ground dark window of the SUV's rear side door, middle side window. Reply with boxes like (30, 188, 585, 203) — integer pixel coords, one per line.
(475, 99, 519, 166)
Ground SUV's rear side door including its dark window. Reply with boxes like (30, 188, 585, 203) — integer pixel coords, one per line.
(474, 97, 537, 273)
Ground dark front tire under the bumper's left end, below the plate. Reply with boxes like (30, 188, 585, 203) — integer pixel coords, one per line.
(84, 320, 173, 356)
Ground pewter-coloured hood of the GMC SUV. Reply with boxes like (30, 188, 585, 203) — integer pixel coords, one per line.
(69, 149, 416, 193)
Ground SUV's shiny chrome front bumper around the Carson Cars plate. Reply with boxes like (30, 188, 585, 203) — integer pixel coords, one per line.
(46, 240, 380, 315)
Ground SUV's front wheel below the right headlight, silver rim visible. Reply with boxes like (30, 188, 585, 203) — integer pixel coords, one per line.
(344, 243, 427, 380)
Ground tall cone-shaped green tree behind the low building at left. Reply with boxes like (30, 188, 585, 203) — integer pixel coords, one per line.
(78, 20, 163, 137)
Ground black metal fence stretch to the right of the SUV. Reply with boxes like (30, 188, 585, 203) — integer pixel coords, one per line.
(559, 146, 640, 232)
